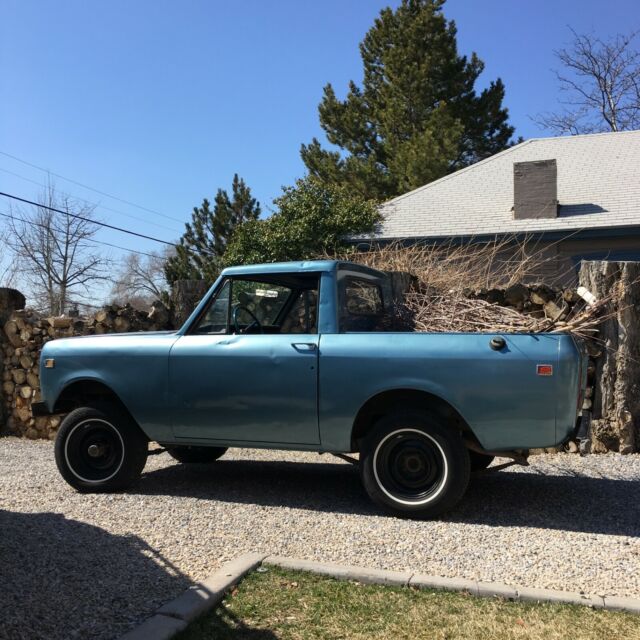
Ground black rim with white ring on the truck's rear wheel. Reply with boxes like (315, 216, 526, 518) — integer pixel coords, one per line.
(373, 429, 448, 504)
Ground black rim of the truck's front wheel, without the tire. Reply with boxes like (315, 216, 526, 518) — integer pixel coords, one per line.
(65, 420, 124, 483)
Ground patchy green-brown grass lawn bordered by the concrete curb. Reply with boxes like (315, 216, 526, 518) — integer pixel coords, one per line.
(177, 567, 640, 640)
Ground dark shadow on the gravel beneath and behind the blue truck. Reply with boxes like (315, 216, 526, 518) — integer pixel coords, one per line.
(138, 459, 640, 537)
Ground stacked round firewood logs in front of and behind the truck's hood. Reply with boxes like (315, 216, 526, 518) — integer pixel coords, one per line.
(0, 302, 169, 439)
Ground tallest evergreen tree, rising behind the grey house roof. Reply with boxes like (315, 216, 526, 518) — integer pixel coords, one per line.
(301, 0, 514, 200)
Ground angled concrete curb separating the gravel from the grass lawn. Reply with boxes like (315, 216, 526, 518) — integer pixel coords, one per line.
(119, 553, 640, 640)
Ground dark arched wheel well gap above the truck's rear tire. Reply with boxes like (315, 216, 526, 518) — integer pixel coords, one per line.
(351, 389, 476, 451)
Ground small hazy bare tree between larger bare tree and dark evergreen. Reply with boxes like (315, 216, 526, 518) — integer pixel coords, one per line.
(111, 247, 175, 308)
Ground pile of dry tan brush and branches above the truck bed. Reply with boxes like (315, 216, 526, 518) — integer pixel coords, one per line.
(345, 241, 610, 338)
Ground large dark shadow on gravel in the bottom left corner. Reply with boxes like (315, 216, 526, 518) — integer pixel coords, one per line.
(0, 510, 192, 640)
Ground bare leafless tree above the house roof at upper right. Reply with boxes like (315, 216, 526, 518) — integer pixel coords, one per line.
(534, 29, 640, 135)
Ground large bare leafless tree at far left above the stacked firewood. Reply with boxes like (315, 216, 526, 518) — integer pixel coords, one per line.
(8, 185, 109, 315)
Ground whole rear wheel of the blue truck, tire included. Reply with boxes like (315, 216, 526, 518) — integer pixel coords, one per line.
(360, 411, 469, 518)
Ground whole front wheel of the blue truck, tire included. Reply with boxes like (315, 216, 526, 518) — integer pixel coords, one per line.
(55, 405, 148, 493)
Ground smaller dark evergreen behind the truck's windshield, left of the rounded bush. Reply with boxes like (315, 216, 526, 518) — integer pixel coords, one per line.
(164, 174, 260, 285)
